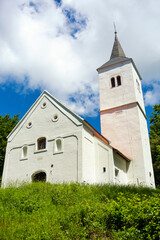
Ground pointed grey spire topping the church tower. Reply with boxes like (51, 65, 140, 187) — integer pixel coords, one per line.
(110, 30, 126, 60)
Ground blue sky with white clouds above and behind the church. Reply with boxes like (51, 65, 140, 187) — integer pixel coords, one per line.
(0, 0, 160, 131)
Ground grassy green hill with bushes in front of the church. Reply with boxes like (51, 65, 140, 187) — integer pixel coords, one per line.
(0, 183, 160, 240)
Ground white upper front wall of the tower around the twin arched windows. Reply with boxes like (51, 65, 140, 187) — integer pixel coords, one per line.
(99, 62, 136, 110)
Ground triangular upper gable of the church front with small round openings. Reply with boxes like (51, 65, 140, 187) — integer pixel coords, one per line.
(8, 91, 83, 144)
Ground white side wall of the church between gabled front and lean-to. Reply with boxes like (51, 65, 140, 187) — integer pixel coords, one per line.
(82, 126, 114, 183)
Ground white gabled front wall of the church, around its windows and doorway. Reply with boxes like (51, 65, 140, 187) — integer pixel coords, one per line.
(2, 96, 82, 185)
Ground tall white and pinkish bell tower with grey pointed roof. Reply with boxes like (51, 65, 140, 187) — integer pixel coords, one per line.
(97, 32, 155, 187)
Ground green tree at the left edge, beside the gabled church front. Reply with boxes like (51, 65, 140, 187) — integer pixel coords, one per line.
(0, 114, 19, 178)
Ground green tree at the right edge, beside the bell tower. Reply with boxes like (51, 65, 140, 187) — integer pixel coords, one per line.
(150, 104, 160, 186)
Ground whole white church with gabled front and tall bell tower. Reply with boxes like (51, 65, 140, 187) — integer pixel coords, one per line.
(2, 32, 155, 188)
